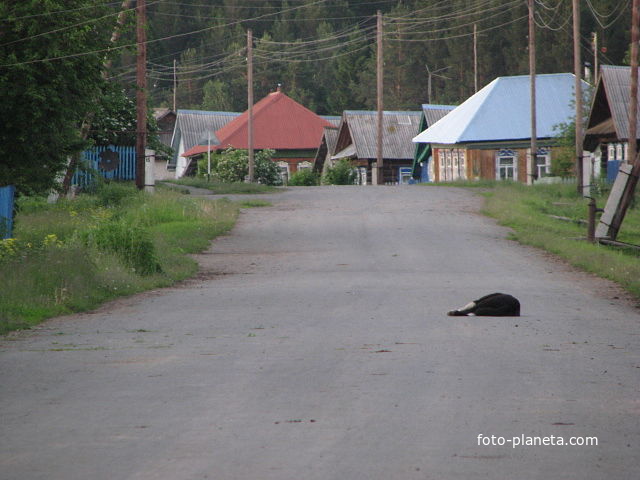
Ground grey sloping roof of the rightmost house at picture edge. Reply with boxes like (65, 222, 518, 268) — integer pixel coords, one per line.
(599, 65, 640, 140)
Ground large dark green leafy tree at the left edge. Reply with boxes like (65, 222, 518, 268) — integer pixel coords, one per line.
(0, 0, 115, 194)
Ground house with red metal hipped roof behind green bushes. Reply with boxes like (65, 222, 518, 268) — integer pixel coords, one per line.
(182, 87, 333, 183)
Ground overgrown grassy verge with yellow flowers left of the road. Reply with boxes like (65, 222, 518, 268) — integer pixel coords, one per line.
(0, 184, 238, 333)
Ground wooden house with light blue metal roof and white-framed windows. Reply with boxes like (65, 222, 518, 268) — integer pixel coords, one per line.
(413, 73, 587, 183)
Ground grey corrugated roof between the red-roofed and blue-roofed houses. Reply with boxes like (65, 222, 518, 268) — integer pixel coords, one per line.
(342, 110, 422, 159)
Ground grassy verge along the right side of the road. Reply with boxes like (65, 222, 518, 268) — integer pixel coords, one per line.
(438, 182, 640, 298)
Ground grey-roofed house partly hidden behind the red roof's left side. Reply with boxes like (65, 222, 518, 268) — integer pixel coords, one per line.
(167, 110, 240, 178)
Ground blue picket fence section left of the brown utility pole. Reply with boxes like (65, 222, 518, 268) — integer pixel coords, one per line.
(71, 145, 136, 186)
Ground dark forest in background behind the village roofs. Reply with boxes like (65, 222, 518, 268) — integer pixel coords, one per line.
(112, 0, 631, 115)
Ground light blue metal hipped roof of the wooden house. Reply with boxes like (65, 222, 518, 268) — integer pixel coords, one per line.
(413, 73, 586, 145)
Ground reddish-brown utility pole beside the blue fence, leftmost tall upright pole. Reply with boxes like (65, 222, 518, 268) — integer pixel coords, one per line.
(136, 0, 147, 190)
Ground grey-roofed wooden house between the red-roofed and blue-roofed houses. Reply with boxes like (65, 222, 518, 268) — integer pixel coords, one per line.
(331, 110, 422, 185)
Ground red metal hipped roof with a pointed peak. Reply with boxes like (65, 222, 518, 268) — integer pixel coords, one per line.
(182, 91, 333, 157)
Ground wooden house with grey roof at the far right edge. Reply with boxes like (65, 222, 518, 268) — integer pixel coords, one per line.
(584, 65, 640, 181)
